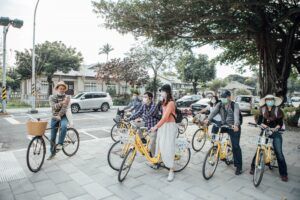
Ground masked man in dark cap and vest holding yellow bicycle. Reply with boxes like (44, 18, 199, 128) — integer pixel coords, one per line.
(205, 90, 243, 175)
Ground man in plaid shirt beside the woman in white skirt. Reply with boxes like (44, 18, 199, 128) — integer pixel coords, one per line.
(128, 92, 159, 156)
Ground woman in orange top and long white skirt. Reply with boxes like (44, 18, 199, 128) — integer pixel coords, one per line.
(151, 84, 178, 181)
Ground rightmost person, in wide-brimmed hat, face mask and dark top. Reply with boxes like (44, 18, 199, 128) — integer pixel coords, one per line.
(250, 95, 288, 182)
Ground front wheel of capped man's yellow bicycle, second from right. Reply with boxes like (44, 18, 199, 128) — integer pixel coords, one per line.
(202, 146, 219, 180)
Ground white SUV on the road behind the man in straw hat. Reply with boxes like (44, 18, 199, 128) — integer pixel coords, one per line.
(71, 92, 113, 113)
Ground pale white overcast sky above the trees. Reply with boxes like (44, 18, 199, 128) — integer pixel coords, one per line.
(0, 0, 251, 78)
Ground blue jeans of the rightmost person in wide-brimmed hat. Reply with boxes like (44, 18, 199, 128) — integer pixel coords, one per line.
(251, 132, 288, 176)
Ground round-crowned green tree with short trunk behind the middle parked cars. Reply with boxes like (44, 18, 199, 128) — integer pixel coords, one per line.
(176, 53, 216, 94)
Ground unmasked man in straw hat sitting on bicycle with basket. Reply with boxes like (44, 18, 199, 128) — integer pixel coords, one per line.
(48, 81, 70, 160)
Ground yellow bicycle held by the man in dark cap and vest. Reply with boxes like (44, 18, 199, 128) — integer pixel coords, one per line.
(202, 125, 233, 180)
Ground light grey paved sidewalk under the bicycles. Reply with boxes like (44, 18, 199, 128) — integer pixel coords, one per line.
(0, 122, 300, 200)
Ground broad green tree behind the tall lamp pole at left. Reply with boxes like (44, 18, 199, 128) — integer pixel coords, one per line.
(16, 41, 83, 95)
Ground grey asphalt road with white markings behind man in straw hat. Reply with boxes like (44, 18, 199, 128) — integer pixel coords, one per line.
(0, 109, 116, 151)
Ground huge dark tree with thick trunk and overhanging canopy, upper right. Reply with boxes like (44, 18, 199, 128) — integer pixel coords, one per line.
(93, 0, 300, 95)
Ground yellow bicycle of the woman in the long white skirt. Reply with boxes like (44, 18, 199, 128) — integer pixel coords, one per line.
(118, 123, 191, 182)
